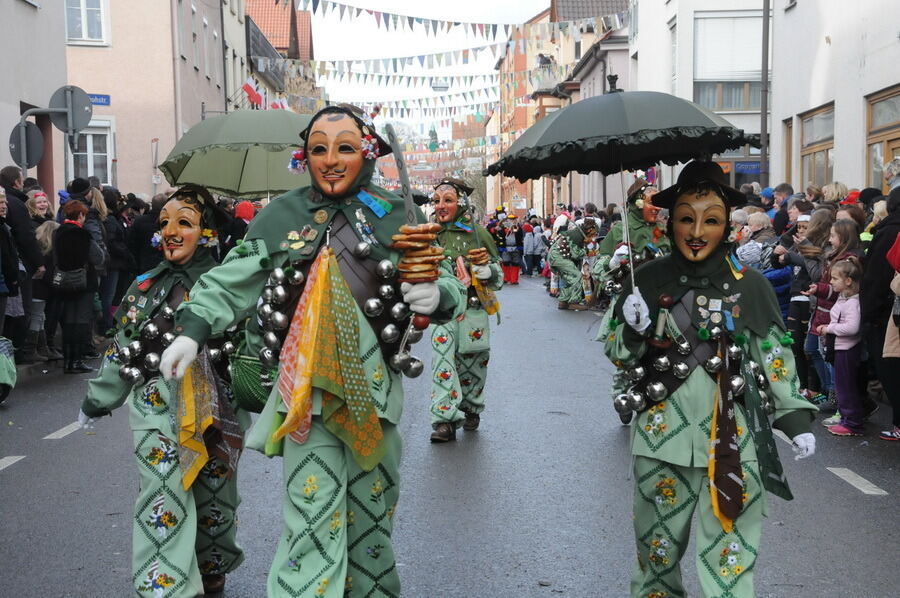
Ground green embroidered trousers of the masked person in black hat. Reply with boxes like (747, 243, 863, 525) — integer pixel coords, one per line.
(631, 456, 765, 598)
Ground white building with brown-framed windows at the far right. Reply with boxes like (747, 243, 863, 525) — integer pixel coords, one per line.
(771, 0, 900, 195)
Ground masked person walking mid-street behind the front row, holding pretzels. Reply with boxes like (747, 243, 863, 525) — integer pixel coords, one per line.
(431, 178, 503, 442)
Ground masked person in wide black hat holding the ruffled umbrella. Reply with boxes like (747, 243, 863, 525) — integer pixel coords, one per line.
(606, 161, 816, 598)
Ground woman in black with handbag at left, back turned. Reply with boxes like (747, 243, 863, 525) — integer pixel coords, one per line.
(51, 201, 103, 374)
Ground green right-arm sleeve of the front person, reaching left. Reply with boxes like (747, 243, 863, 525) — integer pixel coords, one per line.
(175, 239, 272, 345)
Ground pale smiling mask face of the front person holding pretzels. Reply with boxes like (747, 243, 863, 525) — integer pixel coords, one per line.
(306, 113, 364, 202)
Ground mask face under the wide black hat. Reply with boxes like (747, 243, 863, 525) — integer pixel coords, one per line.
(672, 192, 728, 262)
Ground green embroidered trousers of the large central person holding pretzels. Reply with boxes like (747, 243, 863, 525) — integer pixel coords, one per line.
(267, 416, 401, 598)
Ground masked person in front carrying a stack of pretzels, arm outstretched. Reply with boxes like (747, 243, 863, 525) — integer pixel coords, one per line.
(160, 105, 465, 598)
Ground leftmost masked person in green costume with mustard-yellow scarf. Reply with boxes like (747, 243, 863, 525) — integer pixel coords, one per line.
(79, 185, 250, 598)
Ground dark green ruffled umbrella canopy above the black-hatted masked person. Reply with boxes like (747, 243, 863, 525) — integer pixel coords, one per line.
(485, 91, 751, 181)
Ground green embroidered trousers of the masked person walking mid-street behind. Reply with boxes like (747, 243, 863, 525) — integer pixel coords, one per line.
(431, 316, 491, 427)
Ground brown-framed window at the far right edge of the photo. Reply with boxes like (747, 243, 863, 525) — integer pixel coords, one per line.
(866, 85, 900, 193)
